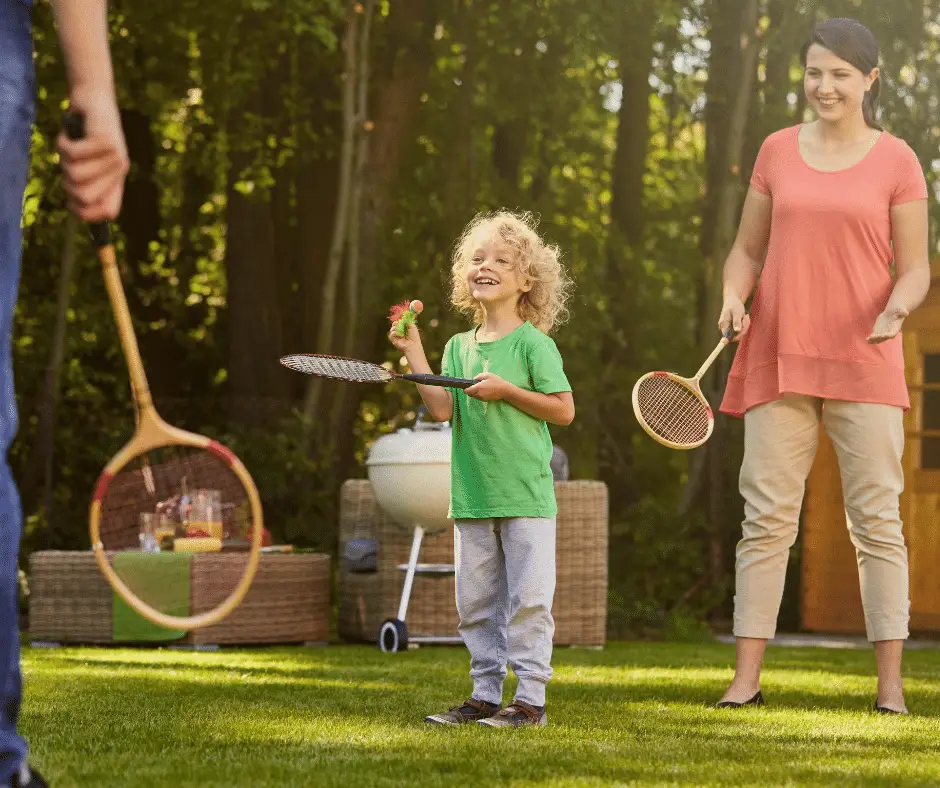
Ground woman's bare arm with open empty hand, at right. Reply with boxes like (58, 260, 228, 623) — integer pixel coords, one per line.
(868, 200, 930, 345)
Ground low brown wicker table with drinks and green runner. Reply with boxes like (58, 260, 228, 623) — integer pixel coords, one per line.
(29, 551, 330, 647)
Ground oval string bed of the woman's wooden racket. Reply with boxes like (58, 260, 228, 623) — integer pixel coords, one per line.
(637, 375, 711, 446)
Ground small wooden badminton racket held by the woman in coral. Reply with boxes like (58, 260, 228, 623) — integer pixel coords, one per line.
(633, 328, 734, 449)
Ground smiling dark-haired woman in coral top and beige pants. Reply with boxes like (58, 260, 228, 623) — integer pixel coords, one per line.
(718, 19, 930, 714)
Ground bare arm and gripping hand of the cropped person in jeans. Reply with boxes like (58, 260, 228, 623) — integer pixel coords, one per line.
(52, 0, 129, 222)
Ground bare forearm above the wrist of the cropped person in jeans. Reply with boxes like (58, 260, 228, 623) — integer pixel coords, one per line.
(52, 0, 114, 92)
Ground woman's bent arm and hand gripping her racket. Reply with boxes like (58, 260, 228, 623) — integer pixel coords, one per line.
(718, 186, 773, 338)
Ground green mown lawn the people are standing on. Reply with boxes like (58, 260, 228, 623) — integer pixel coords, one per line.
(16, 643, 940, 788)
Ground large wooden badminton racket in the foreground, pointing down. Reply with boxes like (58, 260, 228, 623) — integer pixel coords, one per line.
(65, 114, 264, 632)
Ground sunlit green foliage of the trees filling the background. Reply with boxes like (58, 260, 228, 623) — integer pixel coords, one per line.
(11, 0, 940, 639)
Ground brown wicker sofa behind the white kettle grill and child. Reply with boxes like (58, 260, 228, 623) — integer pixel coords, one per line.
(339, 479, 608, 646)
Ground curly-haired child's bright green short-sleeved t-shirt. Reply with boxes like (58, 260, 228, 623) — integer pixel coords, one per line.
(441, 322, 571, 519)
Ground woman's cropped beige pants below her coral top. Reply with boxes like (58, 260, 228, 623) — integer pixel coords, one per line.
(734, 394, 910, 641)
